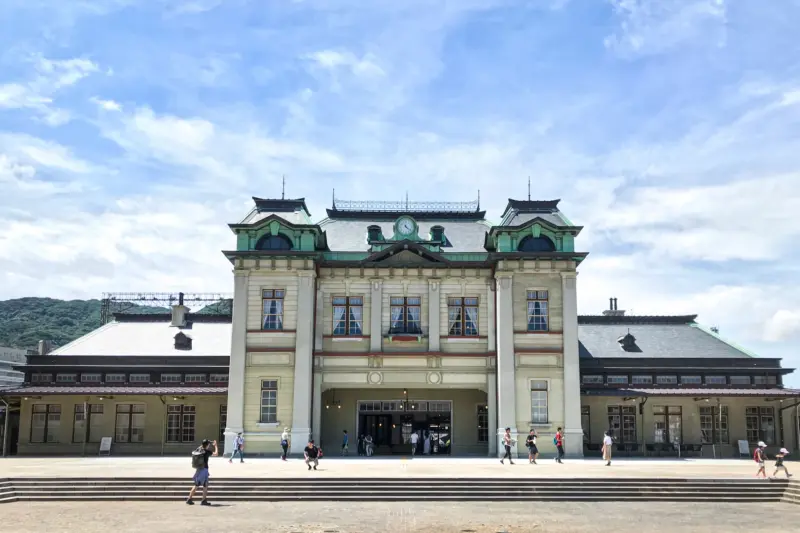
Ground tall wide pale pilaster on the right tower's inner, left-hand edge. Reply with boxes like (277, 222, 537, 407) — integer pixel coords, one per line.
(496, 273, 517, 454)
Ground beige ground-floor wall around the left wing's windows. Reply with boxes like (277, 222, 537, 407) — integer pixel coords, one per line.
(18, 396, 226, 455)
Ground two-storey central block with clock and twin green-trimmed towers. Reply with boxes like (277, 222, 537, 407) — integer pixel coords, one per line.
(224, 198, 586, 456)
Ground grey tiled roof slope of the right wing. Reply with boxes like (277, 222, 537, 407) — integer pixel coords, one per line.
(578, 317, 753, 359)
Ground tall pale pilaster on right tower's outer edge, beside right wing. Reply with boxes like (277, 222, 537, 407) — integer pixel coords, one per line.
(561, 272, 583, 457)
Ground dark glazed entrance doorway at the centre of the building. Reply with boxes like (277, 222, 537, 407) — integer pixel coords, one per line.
(358, 400, 452, 455)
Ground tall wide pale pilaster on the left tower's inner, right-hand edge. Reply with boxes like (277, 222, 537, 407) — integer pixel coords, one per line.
(290, 270, 316, 454)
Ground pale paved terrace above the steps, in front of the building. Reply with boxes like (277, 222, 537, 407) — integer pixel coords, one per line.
(0, 454, 800, 480)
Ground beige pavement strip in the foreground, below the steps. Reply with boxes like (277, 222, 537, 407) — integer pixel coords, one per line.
(2, 502, 800, 533)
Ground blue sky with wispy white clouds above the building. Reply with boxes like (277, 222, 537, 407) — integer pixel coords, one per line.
(0, 0, 800, 386)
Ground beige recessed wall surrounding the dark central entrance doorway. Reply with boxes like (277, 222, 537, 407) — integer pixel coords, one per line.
(320, 389, 488, 456)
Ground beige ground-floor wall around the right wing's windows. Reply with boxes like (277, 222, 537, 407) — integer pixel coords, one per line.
(581, 397, 795, 457)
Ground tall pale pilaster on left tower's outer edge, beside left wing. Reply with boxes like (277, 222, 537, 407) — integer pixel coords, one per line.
(224, 270, 250, 454)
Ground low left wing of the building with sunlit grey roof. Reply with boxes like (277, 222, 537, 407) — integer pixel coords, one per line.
(0, 304, 231, 455)
